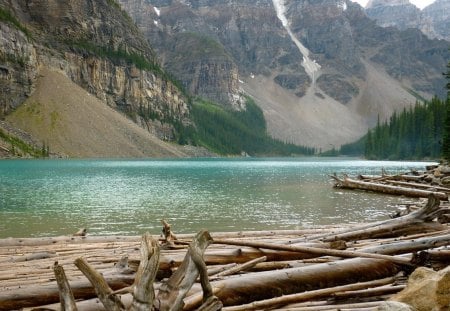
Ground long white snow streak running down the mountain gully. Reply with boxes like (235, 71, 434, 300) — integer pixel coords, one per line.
(272, 0, 320, 86)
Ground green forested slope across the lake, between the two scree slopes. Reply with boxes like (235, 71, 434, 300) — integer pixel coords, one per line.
(183, 98, 316, 156)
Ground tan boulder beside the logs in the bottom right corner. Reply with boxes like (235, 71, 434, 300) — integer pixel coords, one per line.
(390, 266, 450, 311)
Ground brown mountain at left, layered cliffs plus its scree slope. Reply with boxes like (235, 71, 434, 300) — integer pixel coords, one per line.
(0, 0, 197, 156)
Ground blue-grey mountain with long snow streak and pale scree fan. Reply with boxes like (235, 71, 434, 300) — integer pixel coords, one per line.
(119, 0, 450, 149)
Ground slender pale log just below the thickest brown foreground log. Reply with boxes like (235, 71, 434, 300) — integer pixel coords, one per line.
(222, 278, 395, 311)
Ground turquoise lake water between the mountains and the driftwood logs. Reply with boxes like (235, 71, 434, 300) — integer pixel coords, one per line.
(0, 158, 436, 238)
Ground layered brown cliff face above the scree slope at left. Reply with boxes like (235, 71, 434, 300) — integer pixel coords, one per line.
(0, 0, 188, 139)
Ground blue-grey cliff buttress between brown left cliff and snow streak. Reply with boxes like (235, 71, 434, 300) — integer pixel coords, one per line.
(119, 0, 244, 109)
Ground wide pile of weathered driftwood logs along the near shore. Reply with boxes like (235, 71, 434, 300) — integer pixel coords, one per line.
(0, 195, 450, 311)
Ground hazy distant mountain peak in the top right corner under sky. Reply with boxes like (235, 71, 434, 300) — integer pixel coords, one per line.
(366, 0, 450, 41)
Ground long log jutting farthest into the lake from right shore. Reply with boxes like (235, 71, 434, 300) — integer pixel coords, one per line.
(331, 175, 448, 201)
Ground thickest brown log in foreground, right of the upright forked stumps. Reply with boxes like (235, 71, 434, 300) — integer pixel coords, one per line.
(185, 258, 400, 310)
